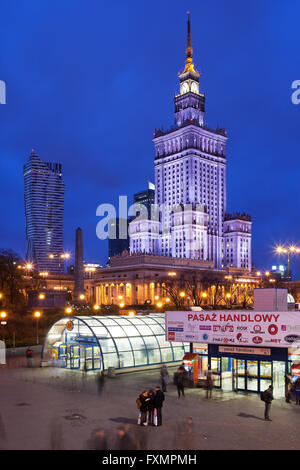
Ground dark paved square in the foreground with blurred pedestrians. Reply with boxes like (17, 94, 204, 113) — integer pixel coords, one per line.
(0, 358, 300, 450)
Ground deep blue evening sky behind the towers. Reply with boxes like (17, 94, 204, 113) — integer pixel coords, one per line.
(0, 0, 300, 278)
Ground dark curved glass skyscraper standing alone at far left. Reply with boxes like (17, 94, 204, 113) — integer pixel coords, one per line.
(24, 150, 65, 272)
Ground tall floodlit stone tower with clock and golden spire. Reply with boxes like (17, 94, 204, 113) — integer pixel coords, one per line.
(129, 16, 251, 270)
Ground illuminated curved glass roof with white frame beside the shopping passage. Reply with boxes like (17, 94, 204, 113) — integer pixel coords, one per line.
(42, 314, 189, 370)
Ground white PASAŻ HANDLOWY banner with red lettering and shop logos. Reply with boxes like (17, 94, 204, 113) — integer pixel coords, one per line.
(165, 310, 300, 348)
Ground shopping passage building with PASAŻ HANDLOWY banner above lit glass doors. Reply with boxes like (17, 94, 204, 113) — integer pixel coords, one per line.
(166, 310, 300, 398)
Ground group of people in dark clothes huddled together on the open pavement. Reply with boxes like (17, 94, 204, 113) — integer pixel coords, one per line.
(136, 385, 165, 426)
